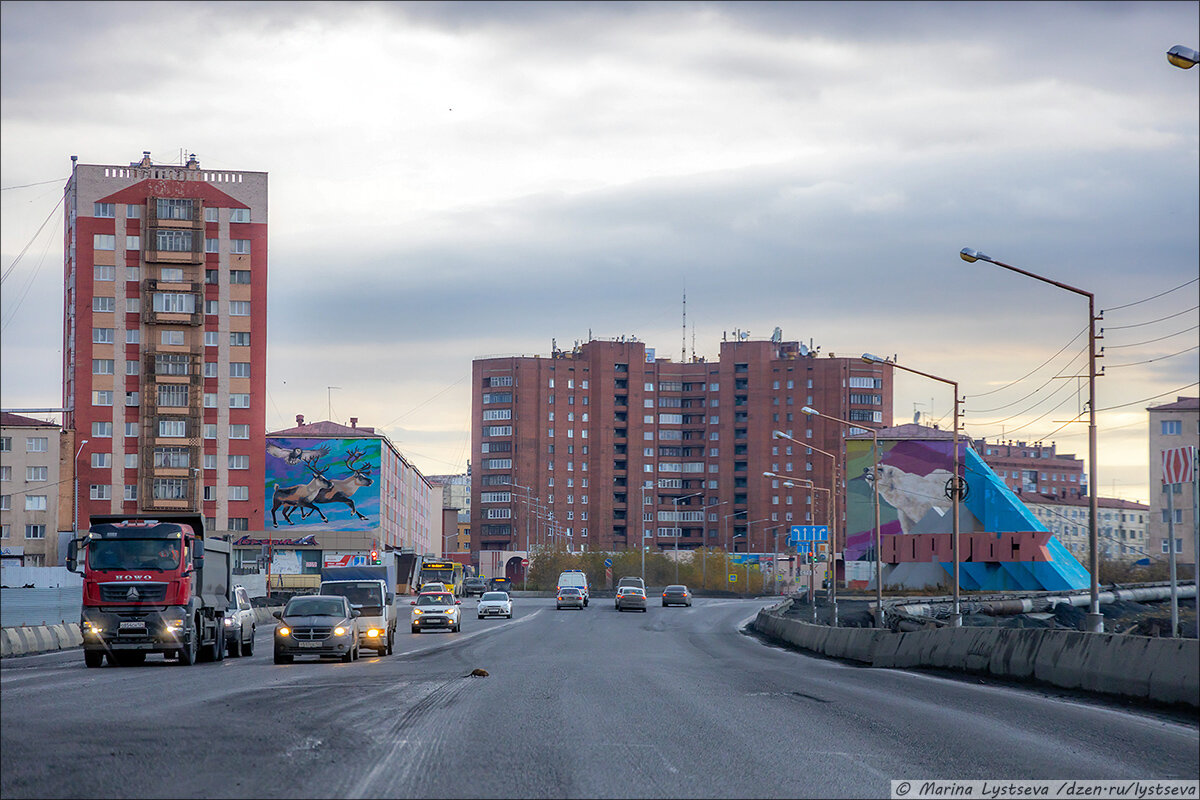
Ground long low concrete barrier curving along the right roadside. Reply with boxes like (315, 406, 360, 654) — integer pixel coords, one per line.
(754, 609, 1200, 708)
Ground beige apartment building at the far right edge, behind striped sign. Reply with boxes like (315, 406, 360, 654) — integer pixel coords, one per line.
(1146, 397, 1200, 569)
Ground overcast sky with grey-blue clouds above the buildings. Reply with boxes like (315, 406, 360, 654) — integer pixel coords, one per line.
(0, 0, 1200, 501)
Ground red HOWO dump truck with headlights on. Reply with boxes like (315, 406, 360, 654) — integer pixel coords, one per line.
(67, 513, 233, 667)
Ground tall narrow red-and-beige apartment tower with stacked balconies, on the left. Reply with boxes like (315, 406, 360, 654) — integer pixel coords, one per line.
(62, 152, 266, 530)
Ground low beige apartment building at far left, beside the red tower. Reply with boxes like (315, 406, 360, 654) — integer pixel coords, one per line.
(0, 411, 73, 566)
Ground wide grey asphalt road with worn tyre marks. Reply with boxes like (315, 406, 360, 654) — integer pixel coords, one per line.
(0, 599, 1200, 799)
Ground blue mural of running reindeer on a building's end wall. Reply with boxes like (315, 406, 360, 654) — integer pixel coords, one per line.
(265, 438, 380, 530)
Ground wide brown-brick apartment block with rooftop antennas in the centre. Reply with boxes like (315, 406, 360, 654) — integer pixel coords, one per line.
(470, 339, 892, 563)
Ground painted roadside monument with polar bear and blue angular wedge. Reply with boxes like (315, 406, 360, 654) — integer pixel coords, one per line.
(845, 425, 1090, 591)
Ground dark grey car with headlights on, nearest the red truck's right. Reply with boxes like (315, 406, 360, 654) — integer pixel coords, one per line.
(275, 595, 359, 664)
